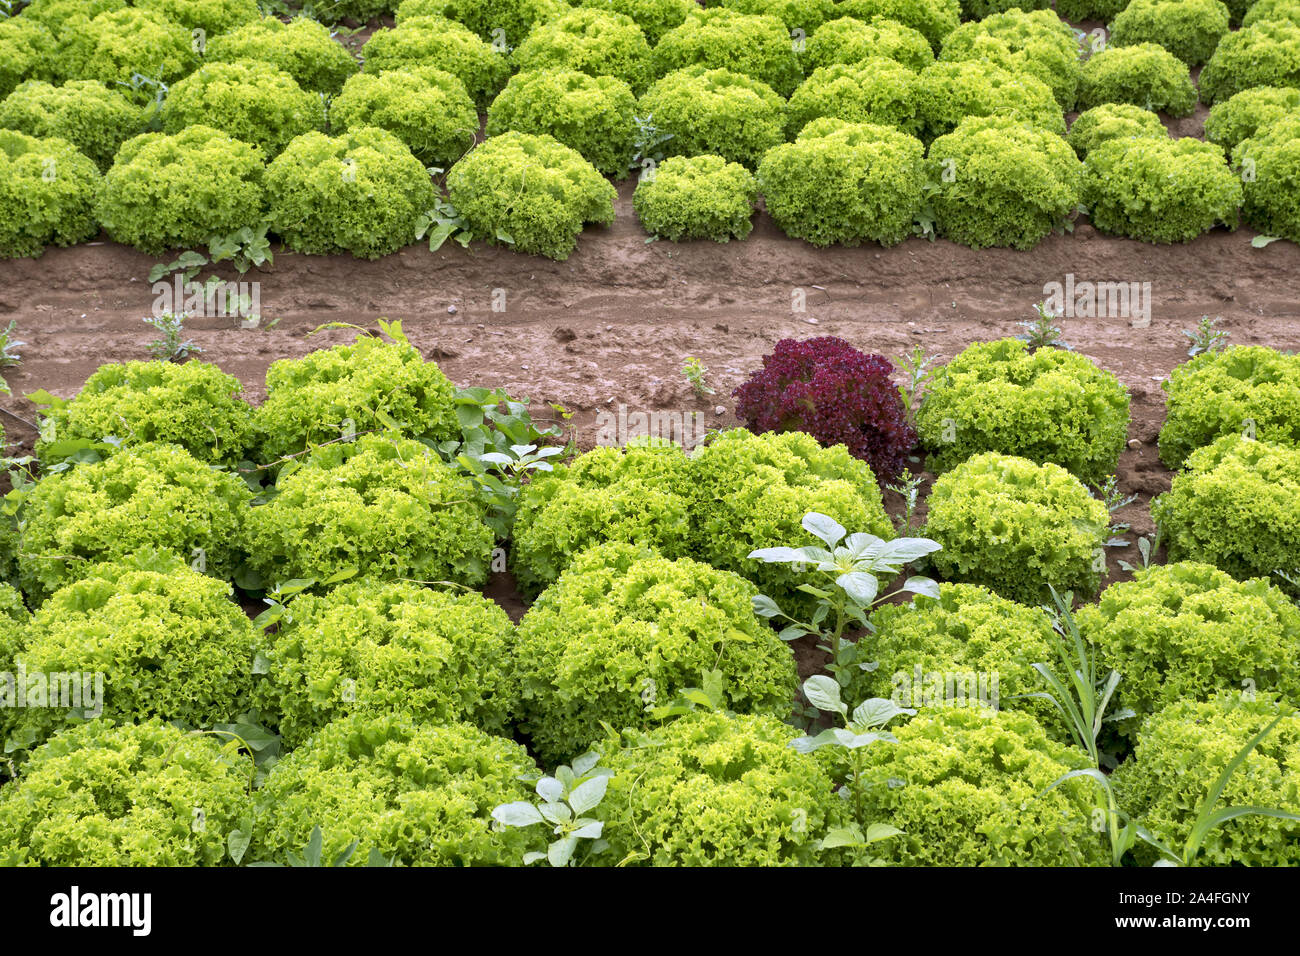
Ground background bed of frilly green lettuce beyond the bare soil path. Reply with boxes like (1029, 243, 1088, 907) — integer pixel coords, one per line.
(0, 0, 1300, 259)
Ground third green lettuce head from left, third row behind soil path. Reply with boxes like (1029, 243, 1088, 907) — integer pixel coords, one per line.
(204, 17, 356, 94)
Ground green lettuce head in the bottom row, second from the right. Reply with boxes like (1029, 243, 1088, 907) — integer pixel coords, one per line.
(862, 708, 1106, 866)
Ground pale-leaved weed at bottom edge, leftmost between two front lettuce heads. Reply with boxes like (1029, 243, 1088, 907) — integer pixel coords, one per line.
(491, 753, 614, 866)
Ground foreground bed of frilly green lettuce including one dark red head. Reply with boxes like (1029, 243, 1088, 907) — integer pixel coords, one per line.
(0, 337, 1300, 865)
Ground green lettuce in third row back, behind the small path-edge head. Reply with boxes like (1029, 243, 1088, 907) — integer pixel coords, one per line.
(651, 8, 803, 96)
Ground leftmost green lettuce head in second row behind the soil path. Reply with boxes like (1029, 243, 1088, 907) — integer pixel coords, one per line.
(0, 79, 143, 172)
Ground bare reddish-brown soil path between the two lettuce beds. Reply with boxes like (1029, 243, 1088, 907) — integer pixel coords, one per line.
(0, 182, 1300, 671)
